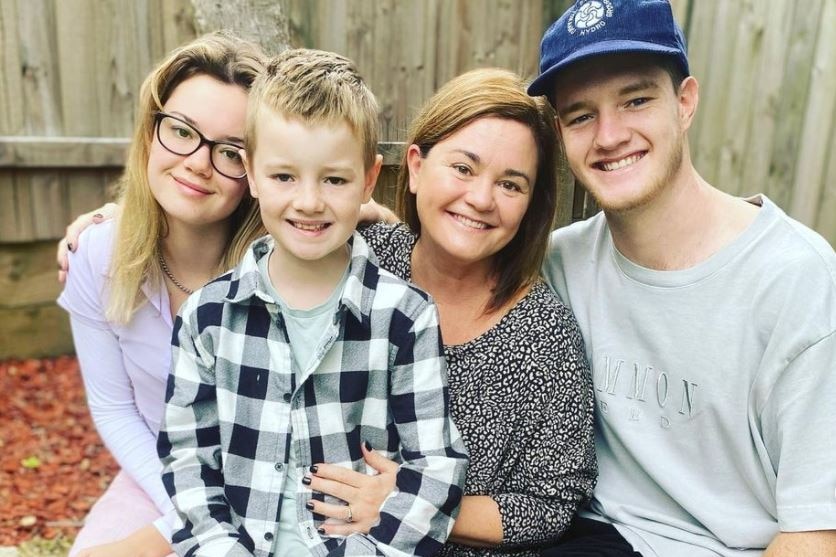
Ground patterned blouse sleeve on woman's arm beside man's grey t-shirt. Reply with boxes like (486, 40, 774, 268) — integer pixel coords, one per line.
(494, 301, 597, 546)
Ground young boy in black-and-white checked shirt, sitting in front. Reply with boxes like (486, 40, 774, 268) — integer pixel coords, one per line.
(159, 50, 466, 556)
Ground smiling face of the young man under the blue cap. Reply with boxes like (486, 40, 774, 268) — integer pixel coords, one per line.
(552, 54, 697, 213)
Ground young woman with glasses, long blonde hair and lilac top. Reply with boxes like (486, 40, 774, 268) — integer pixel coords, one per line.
(58, 34, 263, 556)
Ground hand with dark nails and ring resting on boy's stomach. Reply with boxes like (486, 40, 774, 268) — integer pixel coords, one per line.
(308, 443, 398, 536)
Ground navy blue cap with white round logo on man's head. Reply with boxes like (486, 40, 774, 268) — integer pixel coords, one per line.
(528, 0, 691, 95)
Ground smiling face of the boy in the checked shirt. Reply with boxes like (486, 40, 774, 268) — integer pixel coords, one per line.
(247, 108, 380, 268)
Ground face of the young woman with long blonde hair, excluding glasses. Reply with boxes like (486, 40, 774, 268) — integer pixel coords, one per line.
(147, 75, 247, 227)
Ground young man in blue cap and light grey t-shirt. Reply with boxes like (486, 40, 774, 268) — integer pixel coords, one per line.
(529, 0, 836, 557)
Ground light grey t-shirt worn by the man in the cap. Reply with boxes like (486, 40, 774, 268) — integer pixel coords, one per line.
(544, 196, 836, 557)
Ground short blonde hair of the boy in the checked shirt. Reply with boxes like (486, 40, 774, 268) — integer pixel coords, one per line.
(244, 48, 378, 169)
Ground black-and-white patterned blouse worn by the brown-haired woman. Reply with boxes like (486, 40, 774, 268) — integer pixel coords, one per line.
(361, 223, 597, 557)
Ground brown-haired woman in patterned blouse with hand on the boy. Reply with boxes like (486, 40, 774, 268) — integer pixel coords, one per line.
(310, 69, 596, 556)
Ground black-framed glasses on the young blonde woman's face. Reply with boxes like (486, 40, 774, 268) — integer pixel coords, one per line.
(154, 112, 247, 180)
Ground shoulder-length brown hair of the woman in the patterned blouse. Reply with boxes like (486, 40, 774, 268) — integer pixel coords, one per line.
(396, 68, 558, 311)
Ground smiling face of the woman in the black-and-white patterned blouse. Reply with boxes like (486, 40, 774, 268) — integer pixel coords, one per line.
(407, 117, 537, 264)
